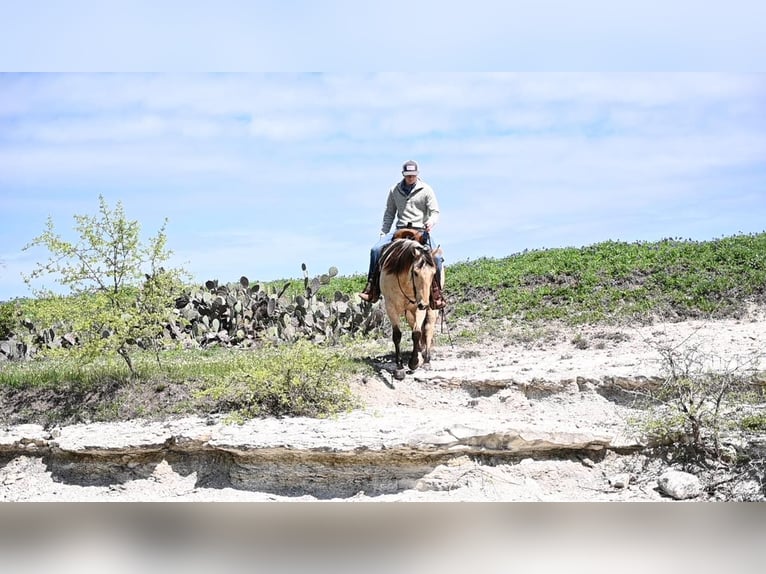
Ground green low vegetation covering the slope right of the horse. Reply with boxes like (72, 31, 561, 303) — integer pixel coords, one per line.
(449, 233, 766, 323)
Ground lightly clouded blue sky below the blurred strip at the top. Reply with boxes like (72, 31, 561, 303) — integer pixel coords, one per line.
(0, 73, 766, 297)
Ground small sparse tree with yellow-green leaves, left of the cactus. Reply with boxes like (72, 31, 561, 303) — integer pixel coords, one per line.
(24, 197, 185, 374)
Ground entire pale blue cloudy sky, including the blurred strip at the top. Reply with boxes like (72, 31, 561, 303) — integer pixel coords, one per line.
(0, 0, 766, 300)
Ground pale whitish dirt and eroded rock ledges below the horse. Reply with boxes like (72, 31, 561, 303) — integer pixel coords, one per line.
(0, 309, 766, 501)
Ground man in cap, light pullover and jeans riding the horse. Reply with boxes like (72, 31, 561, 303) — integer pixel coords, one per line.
(359, 160, 446, 309)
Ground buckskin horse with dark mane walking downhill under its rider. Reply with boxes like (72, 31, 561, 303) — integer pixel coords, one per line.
(380, 230, 438, 380)
